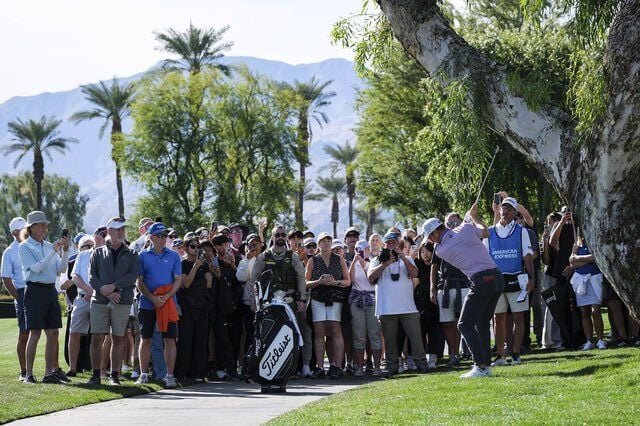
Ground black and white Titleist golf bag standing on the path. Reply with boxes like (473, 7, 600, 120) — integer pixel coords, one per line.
(245, 271, 302, 393)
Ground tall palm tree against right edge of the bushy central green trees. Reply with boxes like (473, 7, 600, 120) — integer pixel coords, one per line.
(291, 77, 336, 227)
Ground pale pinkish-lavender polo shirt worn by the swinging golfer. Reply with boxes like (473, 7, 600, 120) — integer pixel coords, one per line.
(435, 223, 497, 279)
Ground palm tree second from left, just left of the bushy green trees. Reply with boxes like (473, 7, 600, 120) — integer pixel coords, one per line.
(71, 78, 134, 217)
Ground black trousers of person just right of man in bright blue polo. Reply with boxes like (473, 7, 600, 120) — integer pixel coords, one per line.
(175, 306, 209, 379)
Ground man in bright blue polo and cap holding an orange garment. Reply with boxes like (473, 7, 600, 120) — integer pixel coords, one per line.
(136, 222, 182, 388)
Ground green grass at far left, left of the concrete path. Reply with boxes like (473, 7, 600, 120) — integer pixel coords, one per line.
(0, 319, 161, 423)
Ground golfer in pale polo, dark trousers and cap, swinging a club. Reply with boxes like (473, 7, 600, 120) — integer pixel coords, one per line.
(422, 203, 504, 379)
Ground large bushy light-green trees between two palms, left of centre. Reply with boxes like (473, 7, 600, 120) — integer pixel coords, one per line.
(116, 69, 295, 230)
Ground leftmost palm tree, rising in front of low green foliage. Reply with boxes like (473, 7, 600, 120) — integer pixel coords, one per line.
(1, 115, 77, 210)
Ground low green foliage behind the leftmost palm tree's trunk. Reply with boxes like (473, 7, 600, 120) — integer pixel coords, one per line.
(0, 172, 89, 245)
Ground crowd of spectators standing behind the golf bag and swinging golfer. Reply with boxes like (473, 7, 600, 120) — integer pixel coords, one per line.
(1, 196, 640, 388)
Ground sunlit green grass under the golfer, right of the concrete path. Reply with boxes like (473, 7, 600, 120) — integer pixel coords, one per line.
(271, 348, 640, 425)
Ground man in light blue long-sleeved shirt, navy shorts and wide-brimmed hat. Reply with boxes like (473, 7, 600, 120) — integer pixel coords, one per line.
(18, 211, 69, 383)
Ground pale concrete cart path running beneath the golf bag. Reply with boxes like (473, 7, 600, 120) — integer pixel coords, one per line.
(12, 377, 370, 426)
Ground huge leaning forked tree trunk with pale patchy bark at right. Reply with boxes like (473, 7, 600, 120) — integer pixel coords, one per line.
(378, 0, 640, 318)
